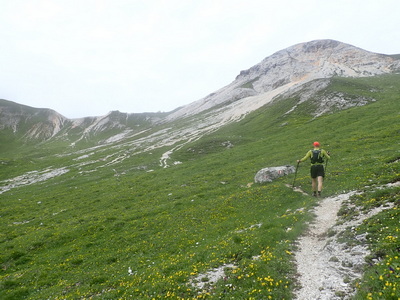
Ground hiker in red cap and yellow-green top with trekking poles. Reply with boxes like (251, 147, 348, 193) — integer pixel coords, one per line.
(297, 142, 330, 197)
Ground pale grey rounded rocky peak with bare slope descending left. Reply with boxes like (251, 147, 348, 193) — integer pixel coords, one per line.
(167, 39, 400, 120)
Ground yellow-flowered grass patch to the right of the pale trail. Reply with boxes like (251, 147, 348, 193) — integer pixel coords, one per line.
(341, 187, 400, 300)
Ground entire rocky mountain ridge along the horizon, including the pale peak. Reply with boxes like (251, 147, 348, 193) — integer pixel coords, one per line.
(0, 40, 400, 149)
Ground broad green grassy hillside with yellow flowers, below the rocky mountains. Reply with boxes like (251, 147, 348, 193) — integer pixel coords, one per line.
(0, 75, 400, 299)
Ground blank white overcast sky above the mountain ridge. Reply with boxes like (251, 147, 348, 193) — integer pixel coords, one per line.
(0, 0, 400, 118)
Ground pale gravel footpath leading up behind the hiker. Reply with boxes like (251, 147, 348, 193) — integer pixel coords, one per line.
(295, 185, 396, 300)
